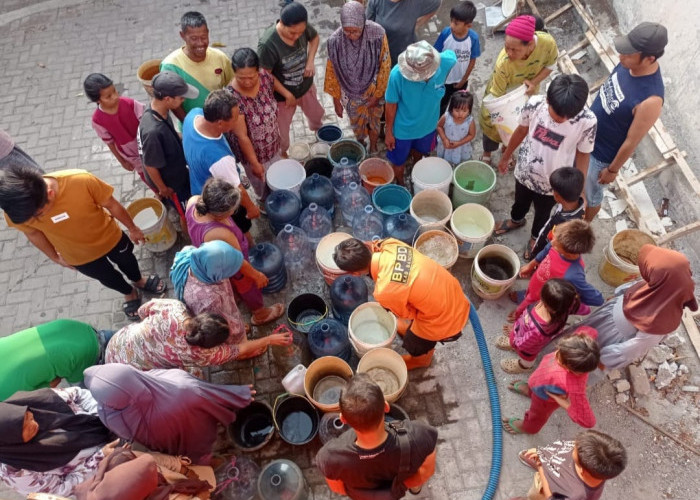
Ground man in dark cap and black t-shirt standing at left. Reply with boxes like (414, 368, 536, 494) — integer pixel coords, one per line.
(136, 71, 199, 208)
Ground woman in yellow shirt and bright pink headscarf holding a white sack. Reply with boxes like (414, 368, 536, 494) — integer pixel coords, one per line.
(479, 16, 559, 163)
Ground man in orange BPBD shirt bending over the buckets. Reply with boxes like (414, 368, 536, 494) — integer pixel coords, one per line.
(333, 238, 470, 370)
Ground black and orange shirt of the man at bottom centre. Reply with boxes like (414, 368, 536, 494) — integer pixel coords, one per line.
(316, 420, 437, 498)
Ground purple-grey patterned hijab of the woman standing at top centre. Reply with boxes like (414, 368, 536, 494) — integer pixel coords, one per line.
(328, 2, 384, 99)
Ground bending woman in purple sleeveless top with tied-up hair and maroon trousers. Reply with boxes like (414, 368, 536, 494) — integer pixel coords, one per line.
(185, 177, 284, 326)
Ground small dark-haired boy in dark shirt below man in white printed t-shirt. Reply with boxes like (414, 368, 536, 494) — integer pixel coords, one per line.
(523, 167, 586, 262)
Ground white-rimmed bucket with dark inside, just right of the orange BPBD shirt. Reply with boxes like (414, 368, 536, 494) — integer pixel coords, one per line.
(472, 245, 520, 300)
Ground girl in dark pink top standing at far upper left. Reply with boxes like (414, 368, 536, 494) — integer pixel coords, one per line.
(83, 73, 158, 194)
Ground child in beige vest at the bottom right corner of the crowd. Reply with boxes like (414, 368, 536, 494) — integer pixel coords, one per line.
(518, 430, 627, 500)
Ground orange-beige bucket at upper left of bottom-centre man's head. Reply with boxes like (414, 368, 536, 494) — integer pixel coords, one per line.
(304, 356, 352, 412)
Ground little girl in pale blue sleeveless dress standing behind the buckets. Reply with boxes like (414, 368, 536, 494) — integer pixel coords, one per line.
(437, 90, 476, 165)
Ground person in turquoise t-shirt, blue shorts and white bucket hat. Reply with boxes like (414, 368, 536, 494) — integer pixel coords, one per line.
(384, 40, 457, 185)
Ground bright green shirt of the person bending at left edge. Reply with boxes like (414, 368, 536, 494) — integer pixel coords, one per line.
(0, 319, 100, 401)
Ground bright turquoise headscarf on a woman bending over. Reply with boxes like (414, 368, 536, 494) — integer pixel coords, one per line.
(170, 240, 243, 300)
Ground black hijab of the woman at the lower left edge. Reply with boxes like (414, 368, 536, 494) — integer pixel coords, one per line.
(0, 389, 110, 472)
